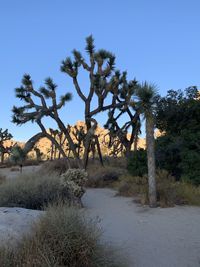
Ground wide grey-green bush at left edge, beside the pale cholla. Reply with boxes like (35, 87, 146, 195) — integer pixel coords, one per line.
(0, 173, 69, 209)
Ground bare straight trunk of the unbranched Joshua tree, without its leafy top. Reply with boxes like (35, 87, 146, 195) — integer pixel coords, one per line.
(146, 115, 157, 207)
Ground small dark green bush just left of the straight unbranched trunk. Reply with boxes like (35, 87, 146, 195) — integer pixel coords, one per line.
(127, 149, 147, 179)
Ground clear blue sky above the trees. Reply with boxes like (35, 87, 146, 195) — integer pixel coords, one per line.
(0, 0, 200, 140)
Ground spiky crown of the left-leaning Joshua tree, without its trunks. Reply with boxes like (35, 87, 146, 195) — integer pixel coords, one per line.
(12, 74, 71, 125)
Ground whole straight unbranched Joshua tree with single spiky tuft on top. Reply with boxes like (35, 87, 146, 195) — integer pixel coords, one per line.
(136, 82, 157, 207)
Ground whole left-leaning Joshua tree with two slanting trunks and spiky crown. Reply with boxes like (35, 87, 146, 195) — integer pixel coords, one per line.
(12, 74, 78, 166)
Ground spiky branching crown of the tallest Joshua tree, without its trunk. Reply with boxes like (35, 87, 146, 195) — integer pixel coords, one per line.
(61, 36, 137, 117)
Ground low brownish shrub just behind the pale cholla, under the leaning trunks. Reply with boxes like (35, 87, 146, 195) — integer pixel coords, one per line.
(40, 158, 79, 175)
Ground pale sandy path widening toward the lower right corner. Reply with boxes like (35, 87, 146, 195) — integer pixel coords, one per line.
(83, 189, 200, 267)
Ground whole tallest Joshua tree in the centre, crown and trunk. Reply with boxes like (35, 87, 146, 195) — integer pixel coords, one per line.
(61, 36, 132, 169)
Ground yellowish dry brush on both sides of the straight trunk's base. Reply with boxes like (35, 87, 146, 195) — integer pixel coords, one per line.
(116, 170, 200, 208)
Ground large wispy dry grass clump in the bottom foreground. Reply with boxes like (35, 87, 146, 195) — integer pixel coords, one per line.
(0, 205, 124, 267)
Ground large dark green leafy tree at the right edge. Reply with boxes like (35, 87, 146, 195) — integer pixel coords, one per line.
(156, 86, 200, 185)
